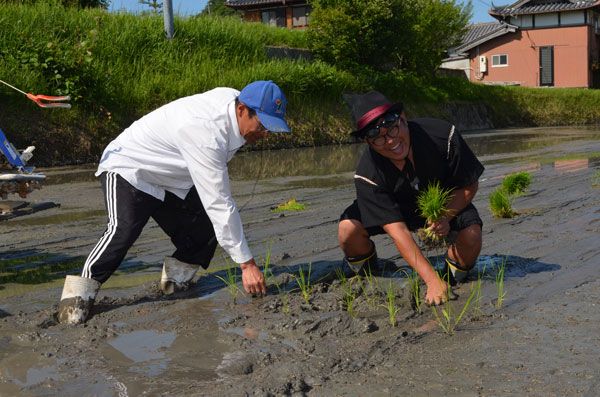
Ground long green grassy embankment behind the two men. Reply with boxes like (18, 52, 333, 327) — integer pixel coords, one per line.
(0, 3, 600, 165)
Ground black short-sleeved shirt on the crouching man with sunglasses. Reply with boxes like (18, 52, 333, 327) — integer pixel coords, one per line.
(354, 118, 484, 229)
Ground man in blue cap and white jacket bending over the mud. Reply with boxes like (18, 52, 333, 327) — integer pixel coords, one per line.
(59, 81, 290, 324)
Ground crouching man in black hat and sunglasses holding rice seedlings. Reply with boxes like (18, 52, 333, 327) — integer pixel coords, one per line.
(338, 91, 483, 304)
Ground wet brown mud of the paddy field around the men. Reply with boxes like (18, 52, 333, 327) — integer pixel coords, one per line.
(0, 130, 600, 396)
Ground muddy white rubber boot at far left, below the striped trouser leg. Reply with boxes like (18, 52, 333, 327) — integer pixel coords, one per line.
(58, 276, 102, 324)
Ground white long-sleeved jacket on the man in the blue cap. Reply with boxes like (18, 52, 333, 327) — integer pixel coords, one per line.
(96, 88, 252, 263)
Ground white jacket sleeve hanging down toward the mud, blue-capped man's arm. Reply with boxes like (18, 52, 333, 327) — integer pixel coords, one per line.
(180, 135, 252, 263)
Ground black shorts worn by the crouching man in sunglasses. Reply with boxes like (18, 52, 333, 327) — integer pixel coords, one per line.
(340, 200, 483, 236)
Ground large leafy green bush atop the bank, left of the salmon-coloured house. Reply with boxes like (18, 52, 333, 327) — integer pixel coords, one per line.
(308, 0, 471, 76)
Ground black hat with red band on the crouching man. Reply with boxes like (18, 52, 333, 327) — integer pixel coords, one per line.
(343, 90, 403, 138)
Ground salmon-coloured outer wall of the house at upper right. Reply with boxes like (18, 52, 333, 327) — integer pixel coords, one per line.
(469, 26, 595, 87)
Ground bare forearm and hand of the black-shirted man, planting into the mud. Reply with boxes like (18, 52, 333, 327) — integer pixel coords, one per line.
(383, 222, 448, 305)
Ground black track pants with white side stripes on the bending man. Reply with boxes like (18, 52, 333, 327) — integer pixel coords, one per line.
(81, 172, 217, 283)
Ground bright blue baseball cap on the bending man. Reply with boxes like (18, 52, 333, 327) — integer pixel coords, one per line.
(238, 80, 292, 134)
